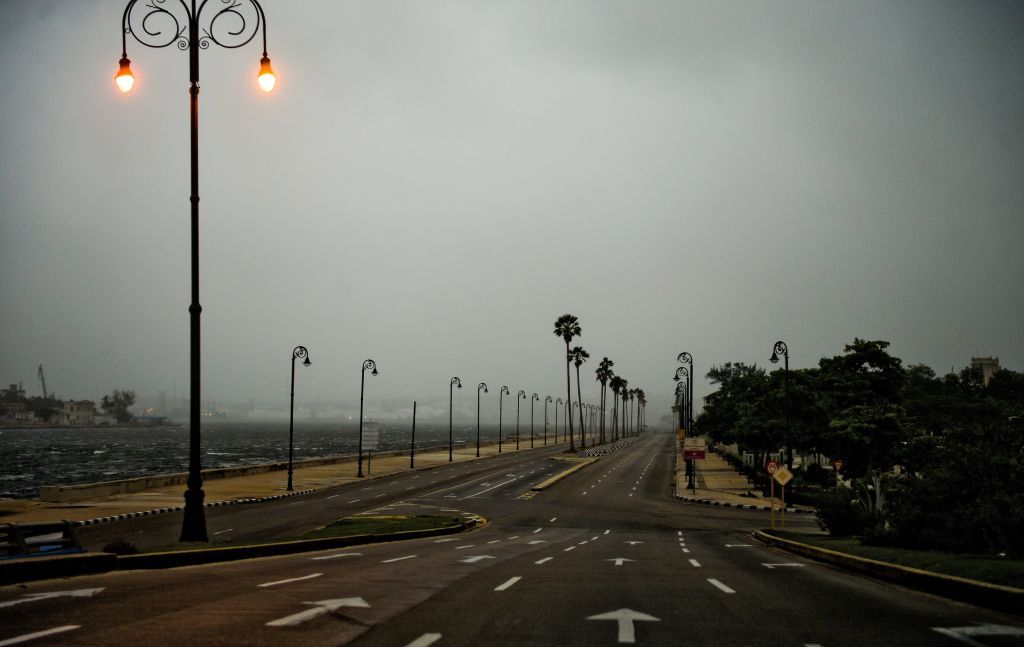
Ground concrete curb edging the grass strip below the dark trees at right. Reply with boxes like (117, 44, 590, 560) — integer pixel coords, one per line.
(751, 530, 1024, 615)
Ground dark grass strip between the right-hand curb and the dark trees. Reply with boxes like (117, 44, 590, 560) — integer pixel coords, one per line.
(765, 530, 1024, 589)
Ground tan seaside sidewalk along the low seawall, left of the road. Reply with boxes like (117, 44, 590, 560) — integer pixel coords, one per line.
(0, 439, 550, 523)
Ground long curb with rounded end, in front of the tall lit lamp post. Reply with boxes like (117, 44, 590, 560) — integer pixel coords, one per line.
(0, 515, 486, 586)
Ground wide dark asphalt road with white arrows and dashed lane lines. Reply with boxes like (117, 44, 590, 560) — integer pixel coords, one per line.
(0, 435, 1024, 647)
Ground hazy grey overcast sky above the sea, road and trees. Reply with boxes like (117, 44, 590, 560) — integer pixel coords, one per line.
(0, 0, 1024, 420)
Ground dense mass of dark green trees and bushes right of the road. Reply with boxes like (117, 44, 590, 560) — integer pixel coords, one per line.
(696, 339, 1024, 555)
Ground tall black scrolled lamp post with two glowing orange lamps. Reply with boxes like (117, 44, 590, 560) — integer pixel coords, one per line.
(114, 0, 276, 542)
